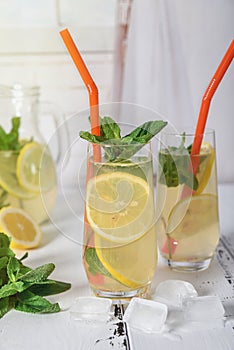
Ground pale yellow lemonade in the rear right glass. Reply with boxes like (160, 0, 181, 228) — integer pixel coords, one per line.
(156, 153, 219, 262)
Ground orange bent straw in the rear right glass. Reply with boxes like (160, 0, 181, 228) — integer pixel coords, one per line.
(191, 40, 234, 174)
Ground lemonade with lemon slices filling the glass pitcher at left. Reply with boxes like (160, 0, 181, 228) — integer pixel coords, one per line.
(0, 140, 57, 223)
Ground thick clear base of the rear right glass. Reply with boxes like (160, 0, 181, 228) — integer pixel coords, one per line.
(163, 258, 212, 272)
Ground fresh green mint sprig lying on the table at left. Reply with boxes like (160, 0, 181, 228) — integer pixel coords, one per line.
(0, 233, 71, 318)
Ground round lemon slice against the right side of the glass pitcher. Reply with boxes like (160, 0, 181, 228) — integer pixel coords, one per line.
(16, 142, 56, 193)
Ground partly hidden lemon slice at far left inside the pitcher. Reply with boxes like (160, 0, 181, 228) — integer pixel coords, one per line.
(0, 151, 35, 198)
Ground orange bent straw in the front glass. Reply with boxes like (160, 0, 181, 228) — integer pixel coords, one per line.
(60, 29, 101, 161)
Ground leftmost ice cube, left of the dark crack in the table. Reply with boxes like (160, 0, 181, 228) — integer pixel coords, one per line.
(70, 297, 112, 322)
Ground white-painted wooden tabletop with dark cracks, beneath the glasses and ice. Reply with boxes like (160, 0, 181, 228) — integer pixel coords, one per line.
(0, 184, 234, 350)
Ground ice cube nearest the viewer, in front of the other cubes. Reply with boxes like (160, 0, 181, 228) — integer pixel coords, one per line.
(123, 298, 167, 333)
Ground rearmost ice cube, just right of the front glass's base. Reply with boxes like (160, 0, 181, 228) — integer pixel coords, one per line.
(152, 279, 198, 307)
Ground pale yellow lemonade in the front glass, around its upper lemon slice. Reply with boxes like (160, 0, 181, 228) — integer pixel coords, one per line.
(83, 157, 157, 295)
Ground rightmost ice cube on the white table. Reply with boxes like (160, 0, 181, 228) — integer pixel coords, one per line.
(183, 295, 225, 322)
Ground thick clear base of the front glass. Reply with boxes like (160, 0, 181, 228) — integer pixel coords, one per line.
(93, 285, 150, 304)
